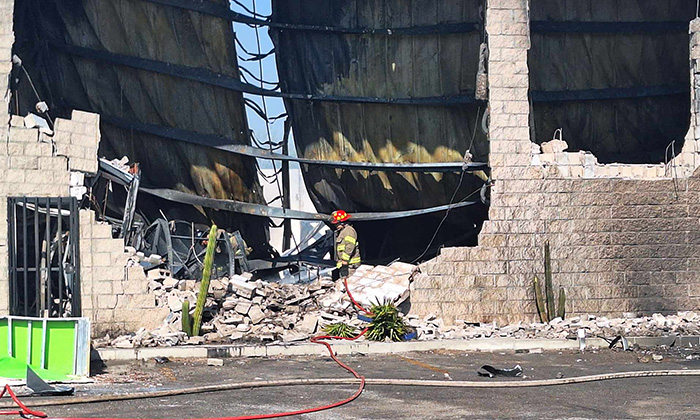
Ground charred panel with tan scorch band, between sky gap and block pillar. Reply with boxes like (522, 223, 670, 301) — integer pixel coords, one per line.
(273, 0, 488, 262)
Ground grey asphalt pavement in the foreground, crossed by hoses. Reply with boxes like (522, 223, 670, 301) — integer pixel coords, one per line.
(20, 349, 700, 419)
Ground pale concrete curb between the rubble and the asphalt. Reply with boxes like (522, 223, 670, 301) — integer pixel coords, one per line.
(91, 336, 700, 361)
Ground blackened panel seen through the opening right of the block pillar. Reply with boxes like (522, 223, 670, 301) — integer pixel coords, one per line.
(528, 0, 696, 163)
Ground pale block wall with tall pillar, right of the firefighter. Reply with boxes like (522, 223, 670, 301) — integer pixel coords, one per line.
(411, 0, 700, 323)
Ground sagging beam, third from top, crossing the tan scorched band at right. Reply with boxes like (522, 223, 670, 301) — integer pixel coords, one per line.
(100, 115, 488, 172)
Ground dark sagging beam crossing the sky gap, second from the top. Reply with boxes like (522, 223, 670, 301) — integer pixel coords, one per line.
(49, 41, 479, 106)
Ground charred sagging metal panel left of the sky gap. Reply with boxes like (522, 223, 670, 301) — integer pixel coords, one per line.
(15, 0, 265, 249)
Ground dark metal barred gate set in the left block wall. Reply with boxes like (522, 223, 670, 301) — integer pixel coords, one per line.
(7, 197, 80, 317)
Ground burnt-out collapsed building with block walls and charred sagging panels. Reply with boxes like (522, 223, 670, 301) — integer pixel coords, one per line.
(0, 0, 700, 334)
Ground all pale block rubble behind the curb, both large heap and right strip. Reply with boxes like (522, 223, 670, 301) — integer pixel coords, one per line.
(93, 260, 700, 350)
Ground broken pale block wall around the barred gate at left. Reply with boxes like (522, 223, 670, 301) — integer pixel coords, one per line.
(0, 0, 165, 335)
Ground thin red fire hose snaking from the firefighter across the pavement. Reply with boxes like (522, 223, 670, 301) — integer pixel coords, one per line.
(0, 279, 372, 420)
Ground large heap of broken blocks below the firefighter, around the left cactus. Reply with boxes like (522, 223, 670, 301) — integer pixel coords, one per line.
(94, 263, 415, 348)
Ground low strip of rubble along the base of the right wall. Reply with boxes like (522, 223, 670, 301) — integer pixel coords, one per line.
(407, 311, 700, 340)
